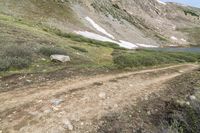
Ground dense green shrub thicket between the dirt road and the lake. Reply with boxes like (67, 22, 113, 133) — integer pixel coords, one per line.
(113, 50, 200, 68)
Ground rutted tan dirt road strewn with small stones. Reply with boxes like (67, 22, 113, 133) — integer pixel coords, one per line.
(0, 64, 199, 133)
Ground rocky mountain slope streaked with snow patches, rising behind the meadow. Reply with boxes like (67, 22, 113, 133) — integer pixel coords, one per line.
(0, 0, 200, 48)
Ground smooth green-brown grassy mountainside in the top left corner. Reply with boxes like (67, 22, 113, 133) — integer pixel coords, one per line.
(0, 0, 79, 25)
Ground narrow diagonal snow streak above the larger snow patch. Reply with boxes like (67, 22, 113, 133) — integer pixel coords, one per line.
(85, 17, 115, 39)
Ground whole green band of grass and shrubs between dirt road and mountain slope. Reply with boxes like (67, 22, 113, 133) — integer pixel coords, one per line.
(0, 8, 200, 76)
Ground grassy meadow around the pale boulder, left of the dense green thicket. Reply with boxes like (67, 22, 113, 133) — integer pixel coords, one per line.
(0, 14, 117, 75)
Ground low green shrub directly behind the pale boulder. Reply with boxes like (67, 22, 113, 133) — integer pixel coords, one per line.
(39, 47, 67, 56)
